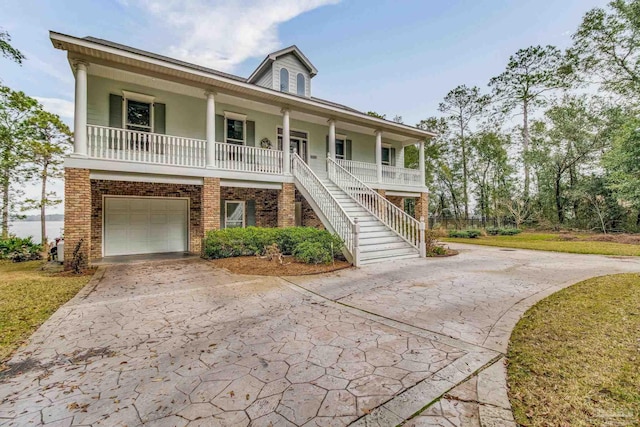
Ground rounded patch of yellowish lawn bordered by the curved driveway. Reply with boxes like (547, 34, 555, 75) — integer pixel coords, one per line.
(507, 274, 640, 426)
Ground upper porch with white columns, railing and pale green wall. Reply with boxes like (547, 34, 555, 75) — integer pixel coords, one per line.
(52, 31, 431, 193)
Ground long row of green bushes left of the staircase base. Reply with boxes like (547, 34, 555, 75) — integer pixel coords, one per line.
(203, 227, 342, 262)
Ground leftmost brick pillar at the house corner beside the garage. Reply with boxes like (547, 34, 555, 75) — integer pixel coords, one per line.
(64, 168, 93, 270)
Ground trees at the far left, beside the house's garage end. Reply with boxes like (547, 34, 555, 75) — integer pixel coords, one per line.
(0, 30, 71, 243)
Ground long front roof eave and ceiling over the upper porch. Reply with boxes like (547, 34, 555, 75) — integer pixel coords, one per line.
(50, 32, 435, 143)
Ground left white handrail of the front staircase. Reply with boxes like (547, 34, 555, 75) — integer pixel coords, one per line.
(291, 153, 360, 267)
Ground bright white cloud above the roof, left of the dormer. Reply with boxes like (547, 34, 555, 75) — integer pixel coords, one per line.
(134, 0, 340, 71)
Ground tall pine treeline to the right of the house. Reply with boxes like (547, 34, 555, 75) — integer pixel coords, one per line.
(405, 0, 640, 232)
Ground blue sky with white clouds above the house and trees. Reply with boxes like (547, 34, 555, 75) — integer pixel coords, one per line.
(0, 0, 607, 214)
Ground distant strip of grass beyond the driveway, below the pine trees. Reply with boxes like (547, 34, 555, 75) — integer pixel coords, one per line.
(442, 233, 640, 256)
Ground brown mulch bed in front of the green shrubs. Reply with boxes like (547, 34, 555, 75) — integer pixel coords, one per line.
(211, 256, 351, 276)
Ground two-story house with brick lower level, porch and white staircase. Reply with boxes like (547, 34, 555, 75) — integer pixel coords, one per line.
(50, 32, 433, 267)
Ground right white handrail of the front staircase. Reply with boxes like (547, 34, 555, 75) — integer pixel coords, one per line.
(327, 157, 426, 257)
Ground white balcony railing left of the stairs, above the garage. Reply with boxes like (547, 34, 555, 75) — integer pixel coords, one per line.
(87, 125, 283, 175)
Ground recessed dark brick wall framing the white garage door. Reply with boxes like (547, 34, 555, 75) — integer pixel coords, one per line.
(90, 180, 202, 258)
